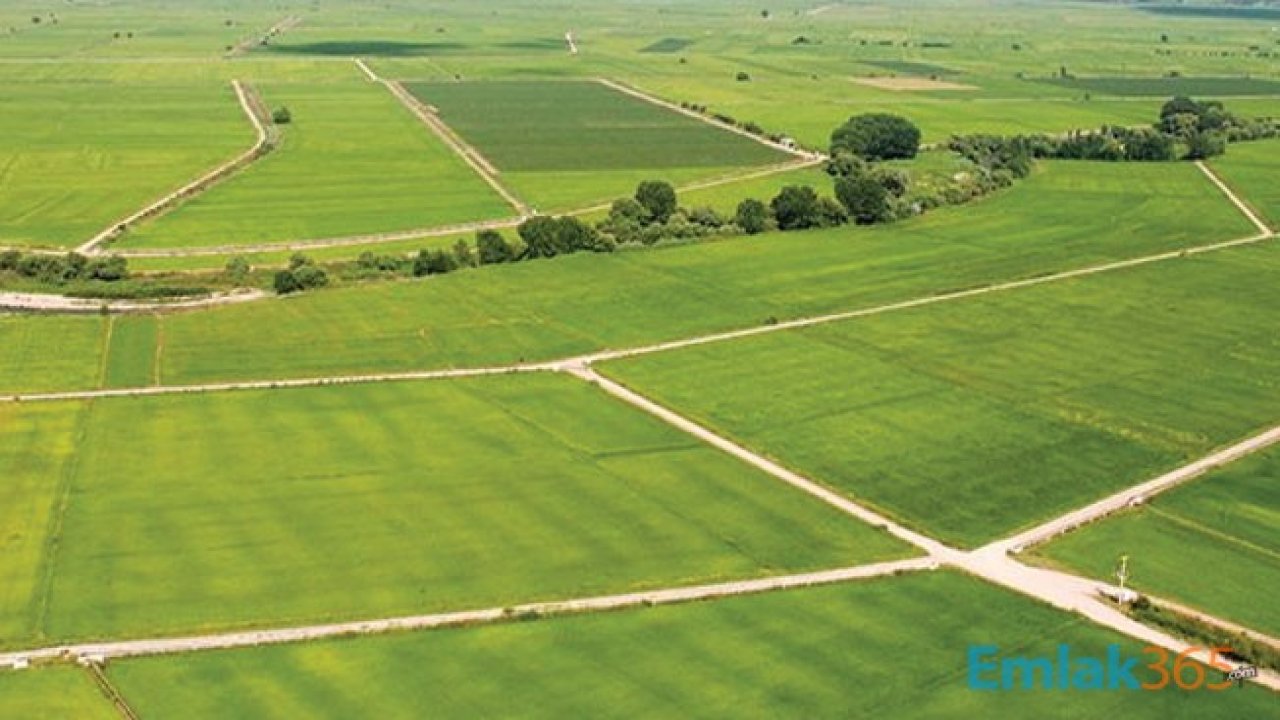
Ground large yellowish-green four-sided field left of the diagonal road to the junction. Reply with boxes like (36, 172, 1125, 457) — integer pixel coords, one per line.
(27, 374, 910, 639)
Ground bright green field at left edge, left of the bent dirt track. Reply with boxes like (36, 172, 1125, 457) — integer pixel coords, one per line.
(0, 81, 253, 247)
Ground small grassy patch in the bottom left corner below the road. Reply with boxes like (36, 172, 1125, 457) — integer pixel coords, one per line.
(0, 667, 119, 720)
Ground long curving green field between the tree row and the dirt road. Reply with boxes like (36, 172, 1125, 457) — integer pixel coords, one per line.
(135, 163, 1251, 383)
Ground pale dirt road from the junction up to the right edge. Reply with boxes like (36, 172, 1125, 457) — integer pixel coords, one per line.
(986, 425, 1280, 553)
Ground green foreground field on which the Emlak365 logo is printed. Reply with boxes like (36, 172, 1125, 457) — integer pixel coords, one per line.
(109, 571, 1275, 720)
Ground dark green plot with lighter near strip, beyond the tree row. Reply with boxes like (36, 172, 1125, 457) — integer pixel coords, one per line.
(406, 81, 792, 208)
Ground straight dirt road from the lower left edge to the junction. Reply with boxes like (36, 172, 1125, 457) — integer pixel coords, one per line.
(0, 557, 937, 666)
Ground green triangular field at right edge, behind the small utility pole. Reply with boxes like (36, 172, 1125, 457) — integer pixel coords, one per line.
(1036, 450, 1280, 637)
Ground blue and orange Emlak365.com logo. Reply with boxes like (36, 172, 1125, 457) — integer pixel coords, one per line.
(965, 644, 1257, 691)
